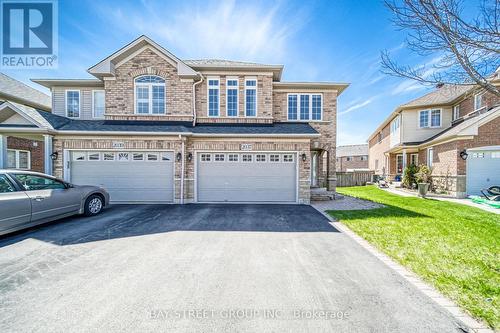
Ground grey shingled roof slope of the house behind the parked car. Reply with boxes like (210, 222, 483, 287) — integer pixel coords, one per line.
(0, 73, 52, 111)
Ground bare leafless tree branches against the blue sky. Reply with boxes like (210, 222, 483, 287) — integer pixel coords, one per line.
(381, 0, 500, 97)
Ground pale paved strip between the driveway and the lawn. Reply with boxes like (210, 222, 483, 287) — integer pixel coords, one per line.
(311, 204, 494, 333)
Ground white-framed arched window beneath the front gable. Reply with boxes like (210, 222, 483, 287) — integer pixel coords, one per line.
(135, 75, 166, 114)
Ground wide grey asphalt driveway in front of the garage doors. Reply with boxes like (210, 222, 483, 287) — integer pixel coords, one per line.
(0, 205, 462, 333)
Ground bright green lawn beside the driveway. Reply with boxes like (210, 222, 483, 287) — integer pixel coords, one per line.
(328, 186, 500, 329)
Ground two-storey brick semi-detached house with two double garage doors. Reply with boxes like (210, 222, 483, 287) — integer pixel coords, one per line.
(0, 36, 348, 203)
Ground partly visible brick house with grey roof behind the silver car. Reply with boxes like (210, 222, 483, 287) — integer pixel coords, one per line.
(0, 73, 52, 172)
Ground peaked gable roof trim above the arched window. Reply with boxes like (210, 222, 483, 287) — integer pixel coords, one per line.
(87, 35, 198, 78)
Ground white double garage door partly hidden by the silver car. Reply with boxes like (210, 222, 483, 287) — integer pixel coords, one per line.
(70, 151, 174, 203)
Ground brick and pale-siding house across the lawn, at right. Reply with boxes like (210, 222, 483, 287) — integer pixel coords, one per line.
(368, 71, 500, 197)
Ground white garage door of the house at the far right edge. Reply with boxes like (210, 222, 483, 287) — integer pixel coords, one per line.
(467, 147, 500, 195)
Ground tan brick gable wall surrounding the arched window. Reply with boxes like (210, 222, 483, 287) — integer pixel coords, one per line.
(104, 49, 193, 120)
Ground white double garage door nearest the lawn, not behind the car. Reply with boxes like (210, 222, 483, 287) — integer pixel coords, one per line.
(197, 152, 297, 202)
